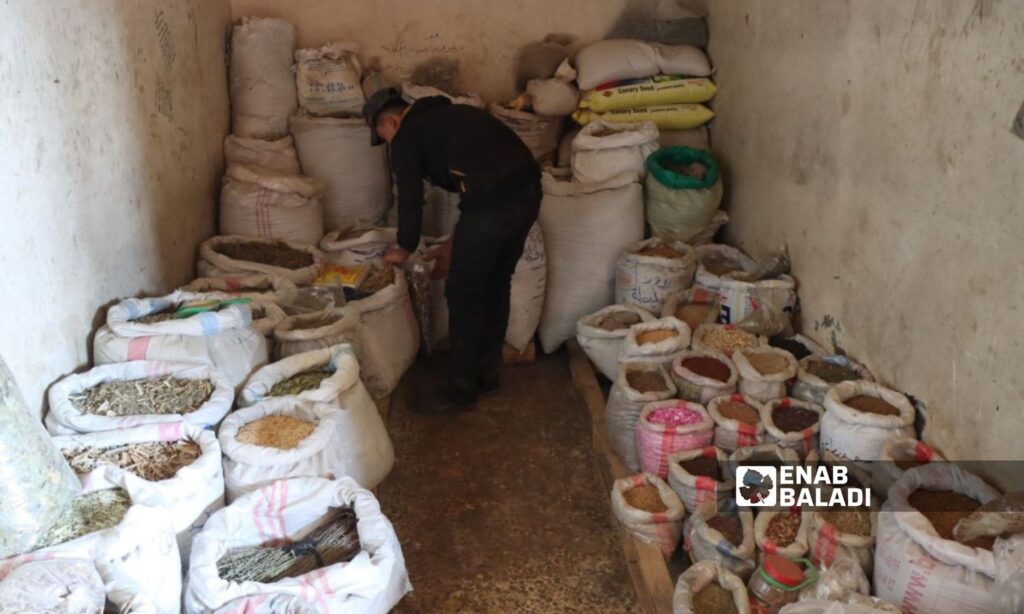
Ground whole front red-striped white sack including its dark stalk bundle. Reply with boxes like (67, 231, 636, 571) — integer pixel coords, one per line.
(184, 477, 412, 614)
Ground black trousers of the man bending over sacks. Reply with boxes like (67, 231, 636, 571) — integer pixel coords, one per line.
(444, 182, 541, 401)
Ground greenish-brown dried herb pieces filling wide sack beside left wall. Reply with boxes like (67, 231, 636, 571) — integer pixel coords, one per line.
(69, 376, 214, 415)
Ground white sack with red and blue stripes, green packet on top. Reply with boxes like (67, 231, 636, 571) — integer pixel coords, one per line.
(92, 292, 267, 388)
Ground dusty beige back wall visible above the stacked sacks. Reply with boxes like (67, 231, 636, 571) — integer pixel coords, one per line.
(231, 0, 696, 101)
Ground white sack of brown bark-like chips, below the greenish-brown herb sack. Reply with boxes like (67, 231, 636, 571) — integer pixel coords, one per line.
(53, 422, 224, 561)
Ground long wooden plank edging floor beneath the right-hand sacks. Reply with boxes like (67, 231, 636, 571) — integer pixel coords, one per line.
(567, 339, 675, 614)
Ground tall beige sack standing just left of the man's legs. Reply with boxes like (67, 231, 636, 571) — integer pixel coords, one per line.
(348, 269, 420, 399)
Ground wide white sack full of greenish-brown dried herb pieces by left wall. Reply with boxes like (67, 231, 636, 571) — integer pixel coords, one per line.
(45, 360, 234, 435)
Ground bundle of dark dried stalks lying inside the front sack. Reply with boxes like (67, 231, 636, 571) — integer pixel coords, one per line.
(217, 508, 361, 583)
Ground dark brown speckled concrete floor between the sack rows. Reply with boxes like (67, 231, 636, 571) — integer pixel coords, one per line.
(380, 353, 637, 613)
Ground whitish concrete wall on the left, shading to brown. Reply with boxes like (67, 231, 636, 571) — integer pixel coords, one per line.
(0, 0, 229, 419)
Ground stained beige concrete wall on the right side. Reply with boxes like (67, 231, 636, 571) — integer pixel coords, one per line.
(710, 0, 1024, 472)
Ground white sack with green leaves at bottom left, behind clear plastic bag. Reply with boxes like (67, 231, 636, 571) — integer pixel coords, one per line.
(0, 489, 181, 614)
